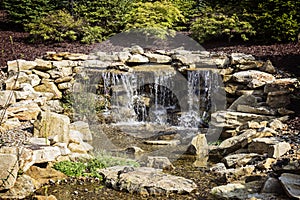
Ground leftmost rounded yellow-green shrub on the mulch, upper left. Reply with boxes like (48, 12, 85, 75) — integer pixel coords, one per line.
(25, 10, 84, 42)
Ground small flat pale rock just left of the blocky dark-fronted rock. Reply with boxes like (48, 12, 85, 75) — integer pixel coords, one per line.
(223, 153, 260, 167)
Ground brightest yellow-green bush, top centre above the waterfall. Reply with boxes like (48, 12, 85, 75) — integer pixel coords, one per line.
(125, 1, 184, 38)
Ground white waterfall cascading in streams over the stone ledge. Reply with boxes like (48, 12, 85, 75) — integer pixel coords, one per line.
(92, 67, 223, 128)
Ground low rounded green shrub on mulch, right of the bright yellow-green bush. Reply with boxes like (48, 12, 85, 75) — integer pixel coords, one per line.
(191, 7, 255, 42)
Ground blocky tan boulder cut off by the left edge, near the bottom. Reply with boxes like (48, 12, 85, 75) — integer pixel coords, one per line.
(0, 153, 19, 190)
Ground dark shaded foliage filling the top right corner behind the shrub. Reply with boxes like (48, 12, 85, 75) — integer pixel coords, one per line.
(205, 0, 300, 42)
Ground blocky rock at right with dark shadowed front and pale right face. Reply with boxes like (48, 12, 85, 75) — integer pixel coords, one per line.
(248, 137, 291, 158)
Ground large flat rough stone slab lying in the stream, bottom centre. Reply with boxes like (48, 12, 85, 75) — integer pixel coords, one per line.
(100, 166, 197, 196)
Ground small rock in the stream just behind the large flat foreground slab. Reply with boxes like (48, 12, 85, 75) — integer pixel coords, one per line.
(147, 156, 175, 170)
